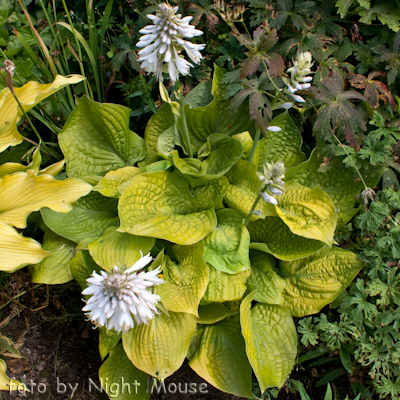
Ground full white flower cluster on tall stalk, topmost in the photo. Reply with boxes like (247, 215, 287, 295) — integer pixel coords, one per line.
(136, 3, 205, 83)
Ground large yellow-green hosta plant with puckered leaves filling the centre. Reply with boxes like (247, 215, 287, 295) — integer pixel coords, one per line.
(33, 67, 383, 399)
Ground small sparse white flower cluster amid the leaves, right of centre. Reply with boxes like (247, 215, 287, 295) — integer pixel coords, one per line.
(257, 161, 287, 205)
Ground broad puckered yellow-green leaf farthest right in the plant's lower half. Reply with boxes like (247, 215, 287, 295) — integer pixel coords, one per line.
(278, 247, 364, 317)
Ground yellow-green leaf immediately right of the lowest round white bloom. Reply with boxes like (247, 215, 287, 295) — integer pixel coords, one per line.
(154, 243, 208, 317)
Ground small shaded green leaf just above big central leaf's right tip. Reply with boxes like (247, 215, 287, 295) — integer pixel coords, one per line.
(191, 176, 229, 211)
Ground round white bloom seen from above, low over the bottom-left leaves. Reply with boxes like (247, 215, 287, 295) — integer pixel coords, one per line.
(82, 254, 164, 333)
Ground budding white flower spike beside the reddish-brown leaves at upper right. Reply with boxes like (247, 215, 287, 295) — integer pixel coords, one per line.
(282, 51, 313, 104)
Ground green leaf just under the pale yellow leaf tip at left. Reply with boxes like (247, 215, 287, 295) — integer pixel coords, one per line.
(41, 193, 119, 243)
